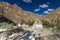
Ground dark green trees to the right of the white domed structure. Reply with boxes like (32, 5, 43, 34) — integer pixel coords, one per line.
(42, 19, 60, 29)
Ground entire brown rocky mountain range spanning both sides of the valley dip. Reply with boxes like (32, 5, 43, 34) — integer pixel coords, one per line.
(0, 2, 60, 23)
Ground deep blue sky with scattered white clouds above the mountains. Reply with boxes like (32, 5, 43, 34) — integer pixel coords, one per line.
(0, 0, 60, 14)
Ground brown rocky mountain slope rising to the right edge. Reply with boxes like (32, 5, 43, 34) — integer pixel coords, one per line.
(43, 7, 60, 23)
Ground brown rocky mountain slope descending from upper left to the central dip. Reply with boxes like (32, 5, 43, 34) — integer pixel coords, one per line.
(0, 2, 40, 23)
